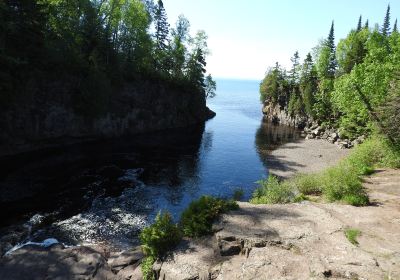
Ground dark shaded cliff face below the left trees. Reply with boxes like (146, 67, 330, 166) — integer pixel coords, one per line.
(0, 81, 215, 155)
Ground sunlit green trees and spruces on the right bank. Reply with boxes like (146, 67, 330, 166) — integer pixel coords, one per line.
(260, 6, 400, 142)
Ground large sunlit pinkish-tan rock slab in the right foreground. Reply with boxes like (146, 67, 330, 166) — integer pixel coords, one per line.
(159, 170, 400, 280)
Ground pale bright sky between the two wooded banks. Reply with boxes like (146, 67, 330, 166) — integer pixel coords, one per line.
(163, 0, 400, 80)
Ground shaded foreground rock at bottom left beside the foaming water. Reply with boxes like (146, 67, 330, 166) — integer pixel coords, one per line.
(0, 244, 143, 280)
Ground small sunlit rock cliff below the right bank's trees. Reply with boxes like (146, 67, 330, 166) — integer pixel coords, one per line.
(262, 101, 312, 129)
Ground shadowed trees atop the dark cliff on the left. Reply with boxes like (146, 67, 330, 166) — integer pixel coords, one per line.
(0, 0, 215, 114)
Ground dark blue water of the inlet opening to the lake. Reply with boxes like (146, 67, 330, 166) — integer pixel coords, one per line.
(0, 80, 299, 247)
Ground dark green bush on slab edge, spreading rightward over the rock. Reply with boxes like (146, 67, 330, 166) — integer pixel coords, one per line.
(181, 196, 239, 237)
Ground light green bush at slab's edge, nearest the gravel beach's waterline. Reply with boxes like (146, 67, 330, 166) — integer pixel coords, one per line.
(250, 175, 295, 204)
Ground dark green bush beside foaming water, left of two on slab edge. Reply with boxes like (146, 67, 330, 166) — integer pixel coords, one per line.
(140, 213, 182, 258)
